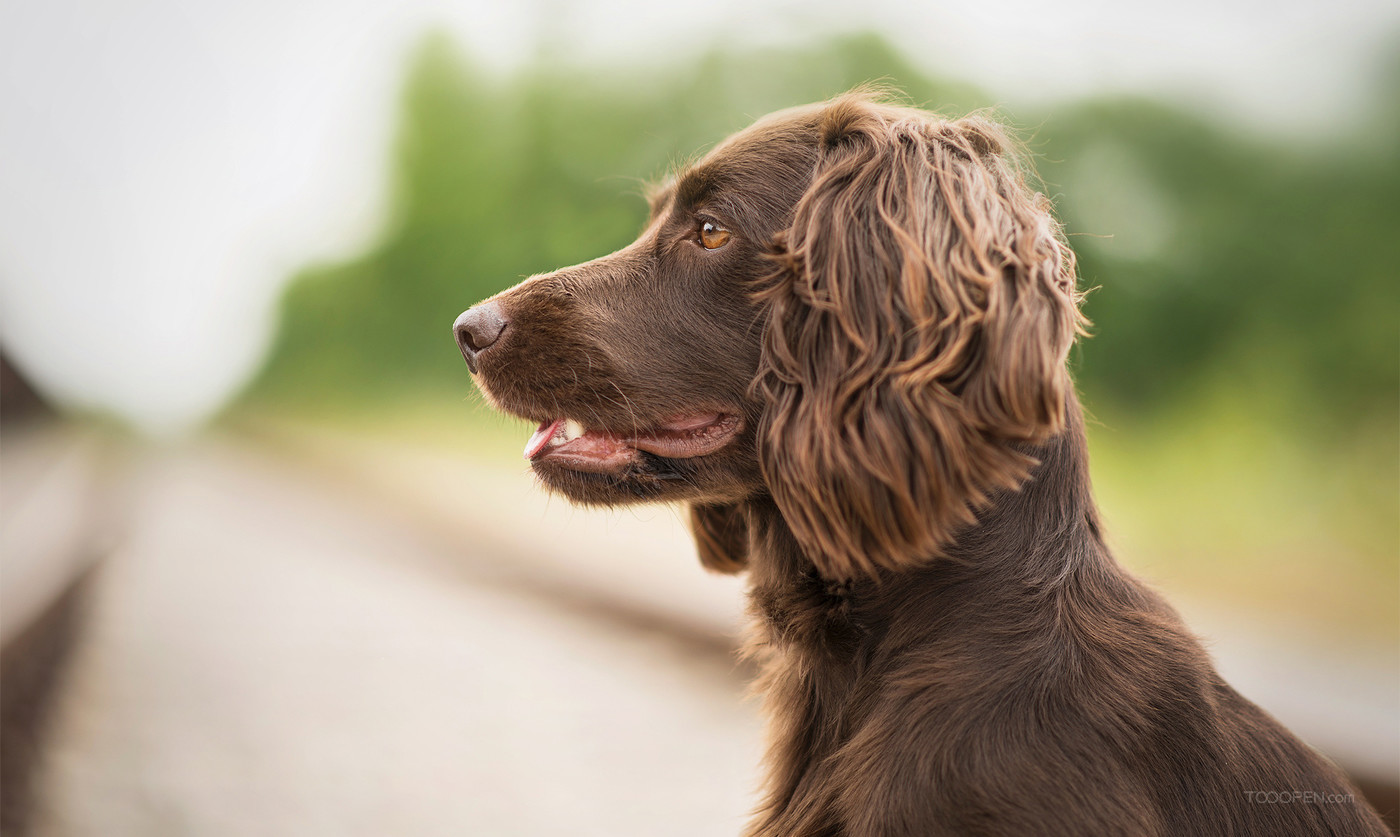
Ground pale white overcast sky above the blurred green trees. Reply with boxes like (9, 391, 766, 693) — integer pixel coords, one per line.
(0, 0, 1400, 431)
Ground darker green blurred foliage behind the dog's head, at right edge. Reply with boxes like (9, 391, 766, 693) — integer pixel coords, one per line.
(1042, 101, 1400, 421)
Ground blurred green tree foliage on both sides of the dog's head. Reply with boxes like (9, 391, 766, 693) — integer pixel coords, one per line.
(235, 35, 1400, 431)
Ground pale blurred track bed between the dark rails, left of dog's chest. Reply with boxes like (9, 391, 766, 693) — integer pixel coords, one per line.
(27, 444, 759, 837)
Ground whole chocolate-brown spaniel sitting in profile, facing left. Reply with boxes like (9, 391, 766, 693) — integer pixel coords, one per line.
(455, 95, 1387, 837)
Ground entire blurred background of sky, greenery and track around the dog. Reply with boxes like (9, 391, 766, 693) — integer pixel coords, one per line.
(0, 0, 1400, 836)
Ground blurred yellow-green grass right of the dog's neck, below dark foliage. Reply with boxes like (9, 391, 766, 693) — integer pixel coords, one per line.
(1089, 388, 1400, 644)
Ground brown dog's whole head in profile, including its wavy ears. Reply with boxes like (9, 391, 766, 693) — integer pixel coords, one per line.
(455, 95, 1082, 578)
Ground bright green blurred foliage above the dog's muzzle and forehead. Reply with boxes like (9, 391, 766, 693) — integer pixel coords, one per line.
(244, 36, 976, 406)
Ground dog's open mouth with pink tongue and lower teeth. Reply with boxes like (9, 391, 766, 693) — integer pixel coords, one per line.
(525, 413, 743, 473)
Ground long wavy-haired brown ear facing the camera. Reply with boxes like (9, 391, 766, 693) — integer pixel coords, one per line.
(755, 99, 1084, 579)
